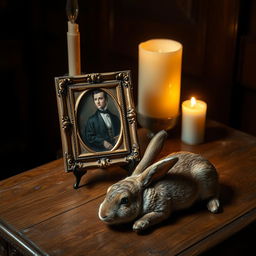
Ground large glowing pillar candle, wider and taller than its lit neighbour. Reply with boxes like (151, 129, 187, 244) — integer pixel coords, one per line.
(138, 39, 182, 119)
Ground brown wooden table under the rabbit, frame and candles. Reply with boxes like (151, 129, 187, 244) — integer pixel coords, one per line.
(0, 122, 256, 256)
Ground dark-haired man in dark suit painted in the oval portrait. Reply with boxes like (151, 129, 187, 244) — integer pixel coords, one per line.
(85, 89, 120, 151)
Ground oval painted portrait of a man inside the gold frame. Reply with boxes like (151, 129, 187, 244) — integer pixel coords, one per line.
(77, 88, 121, 152)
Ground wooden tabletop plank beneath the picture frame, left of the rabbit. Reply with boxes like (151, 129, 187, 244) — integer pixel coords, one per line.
(0, 159, 127, 229)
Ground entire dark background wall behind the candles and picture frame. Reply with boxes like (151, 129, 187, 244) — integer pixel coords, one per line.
(0, 0, 256, 179)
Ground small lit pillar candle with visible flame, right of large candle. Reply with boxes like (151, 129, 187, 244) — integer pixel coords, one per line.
(181, 97, 207, 145)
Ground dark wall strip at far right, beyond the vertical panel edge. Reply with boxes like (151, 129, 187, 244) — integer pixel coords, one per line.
(231, 0, 256, 135)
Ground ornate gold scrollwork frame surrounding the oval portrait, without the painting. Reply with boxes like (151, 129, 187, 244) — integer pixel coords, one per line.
(55, 71, 140, 188)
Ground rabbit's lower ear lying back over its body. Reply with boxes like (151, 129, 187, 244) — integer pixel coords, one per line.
(138, 157, 179, 187)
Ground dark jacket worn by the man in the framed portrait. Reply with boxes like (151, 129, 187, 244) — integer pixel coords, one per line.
(85, 110, 120, 151)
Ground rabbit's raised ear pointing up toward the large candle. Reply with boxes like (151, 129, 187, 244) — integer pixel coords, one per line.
(132, 130, 167, 175)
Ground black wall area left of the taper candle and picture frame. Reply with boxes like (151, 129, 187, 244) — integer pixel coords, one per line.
(0, 1, 67, 177)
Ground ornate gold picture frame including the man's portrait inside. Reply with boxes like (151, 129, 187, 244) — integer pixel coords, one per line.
(55, 71, 140, 188)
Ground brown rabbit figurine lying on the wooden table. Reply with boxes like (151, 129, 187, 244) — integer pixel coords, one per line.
(98, 131, 220, 231)
